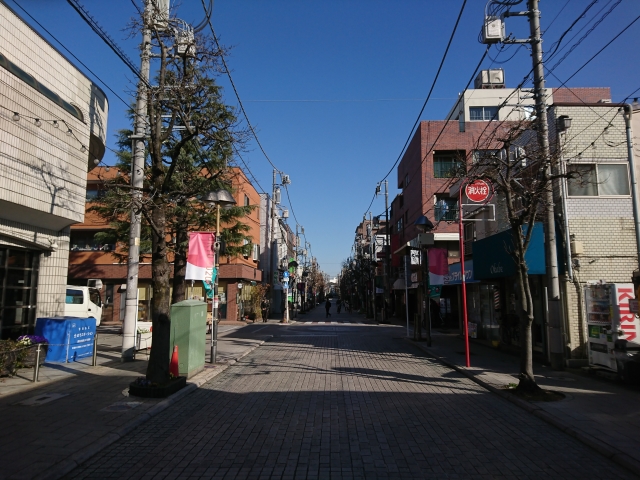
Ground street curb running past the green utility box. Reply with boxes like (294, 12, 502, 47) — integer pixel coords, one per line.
(41, 335, 272, 480)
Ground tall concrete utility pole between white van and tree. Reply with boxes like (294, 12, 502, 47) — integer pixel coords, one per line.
(120, 0, 151, 362)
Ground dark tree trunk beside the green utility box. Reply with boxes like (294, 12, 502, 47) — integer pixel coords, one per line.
(147, 200, 171, 384)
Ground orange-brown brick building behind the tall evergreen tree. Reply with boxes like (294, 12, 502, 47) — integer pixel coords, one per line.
(69, 167, 262, 323)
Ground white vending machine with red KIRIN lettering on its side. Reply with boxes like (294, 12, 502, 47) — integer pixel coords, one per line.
(585, 283, 640, 371)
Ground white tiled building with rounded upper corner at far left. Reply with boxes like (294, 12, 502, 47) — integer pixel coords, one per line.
(0, 1, 108, 338)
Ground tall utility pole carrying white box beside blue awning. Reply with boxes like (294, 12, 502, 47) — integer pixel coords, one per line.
(483, 0, 564, 370)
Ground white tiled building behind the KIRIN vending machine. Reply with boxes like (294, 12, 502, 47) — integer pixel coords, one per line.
(549, 103, 638, 358)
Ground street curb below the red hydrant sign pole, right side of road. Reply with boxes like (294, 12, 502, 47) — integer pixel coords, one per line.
(404, 338, 640, 477)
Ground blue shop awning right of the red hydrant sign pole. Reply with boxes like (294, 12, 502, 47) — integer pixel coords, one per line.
(473, 223, 547, 280)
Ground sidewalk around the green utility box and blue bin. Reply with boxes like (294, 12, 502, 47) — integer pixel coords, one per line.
(0, 327, 272, 479)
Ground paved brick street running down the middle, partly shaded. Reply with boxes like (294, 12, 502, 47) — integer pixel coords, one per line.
(68, 309, 635, 479)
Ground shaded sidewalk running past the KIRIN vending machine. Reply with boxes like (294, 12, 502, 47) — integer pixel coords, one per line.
(411, 332, 640, 476)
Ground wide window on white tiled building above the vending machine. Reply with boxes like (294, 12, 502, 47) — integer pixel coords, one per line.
(567, 163, 629, 197)
